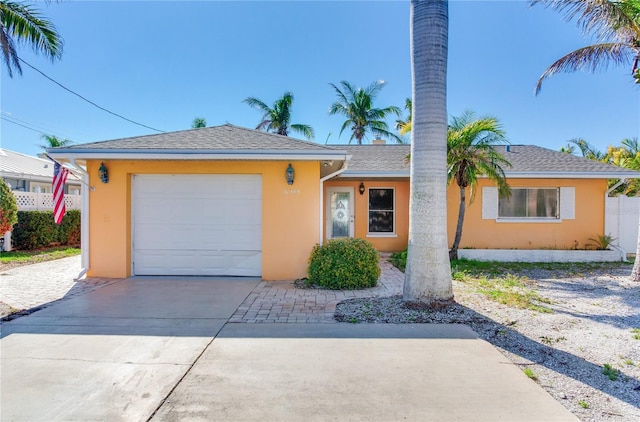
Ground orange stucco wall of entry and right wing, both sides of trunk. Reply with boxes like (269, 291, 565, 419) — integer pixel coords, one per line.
(323, 179, 607, 251)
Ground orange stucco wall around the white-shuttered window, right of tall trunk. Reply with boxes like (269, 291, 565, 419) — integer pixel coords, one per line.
(447, 179, 607, 249)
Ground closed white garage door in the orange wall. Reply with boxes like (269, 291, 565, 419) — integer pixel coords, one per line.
(132, 174, 262, 276)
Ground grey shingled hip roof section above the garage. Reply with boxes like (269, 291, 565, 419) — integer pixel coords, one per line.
(48, 124, 344, 158)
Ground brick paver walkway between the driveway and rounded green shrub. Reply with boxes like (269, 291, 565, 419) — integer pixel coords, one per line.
(229, 255, 404, 323)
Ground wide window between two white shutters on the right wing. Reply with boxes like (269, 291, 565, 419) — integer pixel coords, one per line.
(498, 188, 560, 219)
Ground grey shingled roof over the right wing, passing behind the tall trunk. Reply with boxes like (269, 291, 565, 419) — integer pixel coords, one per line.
(339, 144, 640, 179)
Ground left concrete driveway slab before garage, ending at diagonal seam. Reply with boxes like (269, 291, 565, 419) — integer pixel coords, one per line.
(0, 277, 259, 421)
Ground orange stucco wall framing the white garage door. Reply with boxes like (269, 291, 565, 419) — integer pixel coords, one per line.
(87, 160, 320, 280)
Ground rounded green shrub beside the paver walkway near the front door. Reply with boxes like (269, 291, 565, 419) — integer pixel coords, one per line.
(309, 239, 380, 290)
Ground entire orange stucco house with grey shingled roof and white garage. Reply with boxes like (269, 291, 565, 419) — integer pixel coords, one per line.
(48, 124, 640, 280)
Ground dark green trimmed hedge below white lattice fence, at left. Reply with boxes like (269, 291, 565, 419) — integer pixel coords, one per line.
(11, 210, 80, 250)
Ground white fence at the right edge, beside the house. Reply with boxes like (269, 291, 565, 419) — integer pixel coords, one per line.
(604, 195, 640, 253)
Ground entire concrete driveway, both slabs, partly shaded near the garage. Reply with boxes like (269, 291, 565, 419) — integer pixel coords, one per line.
(0, 277, 576, 421)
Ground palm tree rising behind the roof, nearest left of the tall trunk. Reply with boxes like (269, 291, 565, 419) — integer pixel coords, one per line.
(329, 81, 402, 145)
